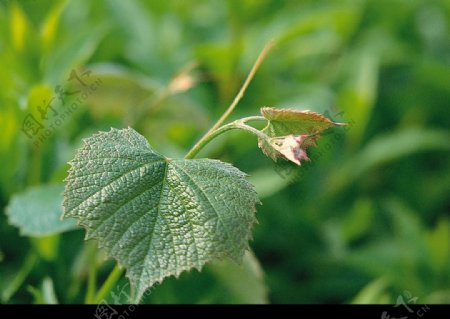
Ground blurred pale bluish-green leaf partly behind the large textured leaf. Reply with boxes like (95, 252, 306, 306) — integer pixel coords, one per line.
(6, 184, 76, 237)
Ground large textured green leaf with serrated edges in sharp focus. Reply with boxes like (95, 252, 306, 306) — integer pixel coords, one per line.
(64, 128, 259, 302)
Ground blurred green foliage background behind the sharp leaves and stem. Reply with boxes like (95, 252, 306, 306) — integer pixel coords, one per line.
(0, 0, 450, 303)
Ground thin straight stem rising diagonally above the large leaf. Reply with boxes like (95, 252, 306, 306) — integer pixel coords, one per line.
(185, 41, 274, 158)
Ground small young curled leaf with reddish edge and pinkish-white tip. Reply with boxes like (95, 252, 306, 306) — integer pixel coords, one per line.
(258, 107, 345, 165)
